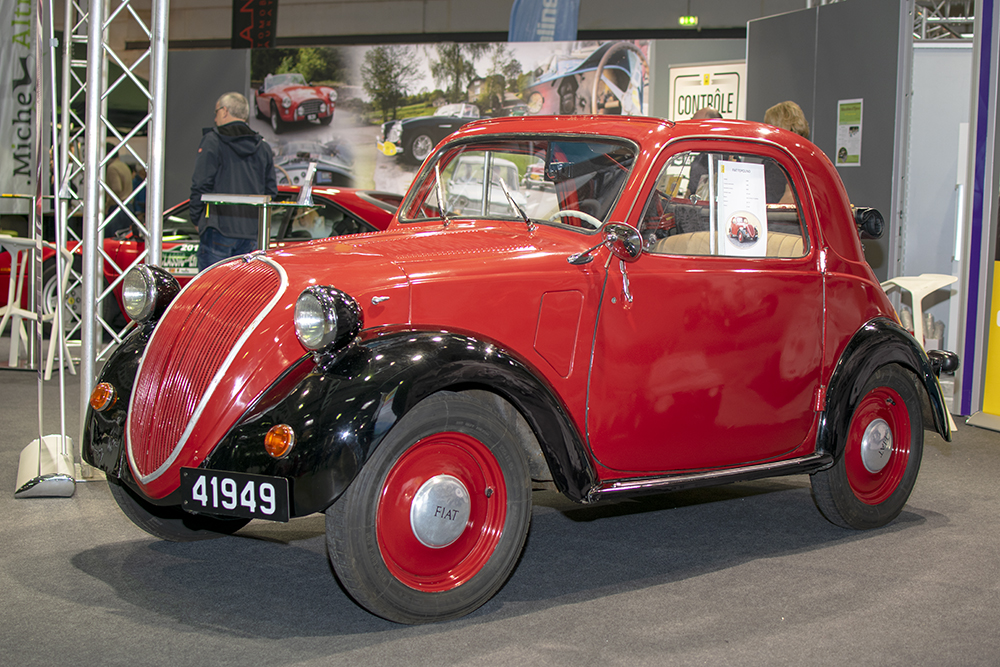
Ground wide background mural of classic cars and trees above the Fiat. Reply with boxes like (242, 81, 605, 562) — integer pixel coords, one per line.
(247, 40, 651, 193)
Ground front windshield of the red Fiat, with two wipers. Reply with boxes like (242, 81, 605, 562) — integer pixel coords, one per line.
(400, 137, 636, 230)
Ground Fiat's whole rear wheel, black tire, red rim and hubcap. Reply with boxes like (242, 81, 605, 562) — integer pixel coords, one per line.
(811, 365, 924, 530)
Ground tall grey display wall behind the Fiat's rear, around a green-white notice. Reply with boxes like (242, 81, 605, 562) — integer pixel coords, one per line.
(747, 0, 912, 280)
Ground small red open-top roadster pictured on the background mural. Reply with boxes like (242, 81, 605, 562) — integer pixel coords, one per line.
(253, 72, 337, 134)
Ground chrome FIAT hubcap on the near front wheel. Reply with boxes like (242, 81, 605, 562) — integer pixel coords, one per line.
(410, 475, 472, 549)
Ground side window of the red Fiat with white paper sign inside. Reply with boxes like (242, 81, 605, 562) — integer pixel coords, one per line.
(639, 151, 809, 257)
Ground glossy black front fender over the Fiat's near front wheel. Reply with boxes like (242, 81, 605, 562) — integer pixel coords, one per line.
(203, 331, 595, 516)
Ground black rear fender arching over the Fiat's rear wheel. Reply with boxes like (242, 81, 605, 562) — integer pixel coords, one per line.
(816, 318, 951, 459)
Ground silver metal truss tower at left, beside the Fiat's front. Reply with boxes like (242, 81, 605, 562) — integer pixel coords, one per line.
(54, 0, 170, 474)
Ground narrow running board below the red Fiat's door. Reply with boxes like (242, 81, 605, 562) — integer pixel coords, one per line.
(587, 454, 833, 502)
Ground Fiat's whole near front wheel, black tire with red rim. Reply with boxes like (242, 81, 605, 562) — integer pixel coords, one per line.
(326, 391, 531, 623)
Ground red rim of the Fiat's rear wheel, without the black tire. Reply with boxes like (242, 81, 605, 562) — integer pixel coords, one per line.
(844, 387, 910, 505)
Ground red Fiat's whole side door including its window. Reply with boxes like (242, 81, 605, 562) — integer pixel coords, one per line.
(587, 144, 824, 474)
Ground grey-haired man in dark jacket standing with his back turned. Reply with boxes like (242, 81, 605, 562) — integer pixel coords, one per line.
(189, 93, 278, 271)
